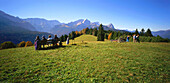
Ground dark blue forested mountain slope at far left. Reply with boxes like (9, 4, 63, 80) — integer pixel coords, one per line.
(0, 11, 53, 44)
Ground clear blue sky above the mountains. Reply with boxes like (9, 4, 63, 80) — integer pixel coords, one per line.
(0, 0, 170, 31)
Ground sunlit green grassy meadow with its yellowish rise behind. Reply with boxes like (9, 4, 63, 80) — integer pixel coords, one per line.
(0, 35, 170, 83)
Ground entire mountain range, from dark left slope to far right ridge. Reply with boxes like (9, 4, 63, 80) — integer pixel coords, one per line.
(0, 11, 170, 44)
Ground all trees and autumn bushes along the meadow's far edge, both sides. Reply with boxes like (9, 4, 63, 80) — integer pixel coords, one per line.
(1, 24, 170, 49)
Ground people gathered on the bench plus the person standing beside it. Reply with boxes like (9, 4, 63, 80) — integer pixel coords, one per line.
(34, 35, 69, 50)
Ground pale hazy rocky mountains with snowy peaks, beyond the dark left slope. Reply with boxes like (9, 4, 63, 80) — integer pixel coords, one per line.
(23, 18, 116, 36)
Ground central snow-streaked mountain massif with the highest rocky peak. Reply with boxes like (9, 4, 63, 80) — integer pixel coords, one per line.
(50, 19, 115, 36)
